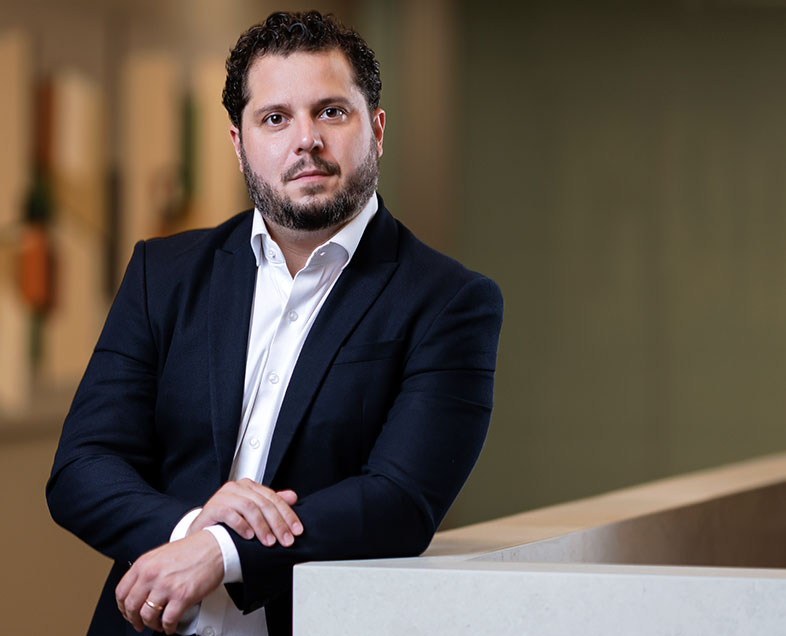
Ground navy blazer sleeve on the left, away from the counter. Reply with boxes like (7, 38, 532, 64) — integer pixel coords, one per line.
(46, 242, 189, 562)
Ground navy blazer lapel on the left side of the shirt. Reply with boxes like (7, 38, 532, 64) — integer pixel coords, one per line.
(207, 215, 256, 483)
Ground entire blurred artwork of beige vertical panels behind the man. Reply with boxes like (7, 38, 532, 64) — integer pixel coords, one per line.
(0, 26, 248, 423)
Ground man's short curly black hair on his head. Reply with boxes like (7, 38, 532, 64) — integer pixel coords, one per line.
(222, 11, 382, 128)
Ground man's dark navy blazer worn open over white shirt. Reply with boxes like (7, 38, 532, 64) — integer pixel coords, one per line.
(47, 200, 502, 636)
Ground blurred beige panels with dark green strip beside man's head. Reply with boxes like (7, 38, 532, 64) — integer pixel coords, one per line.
(117, 52, 248, 272)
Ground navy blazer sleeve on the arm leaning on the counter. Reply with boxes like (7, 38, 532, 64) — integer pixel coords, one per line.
(227, 277, 502, 612)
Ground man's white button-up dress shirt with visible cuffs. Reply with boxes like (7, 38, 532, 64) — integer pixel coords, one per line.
(170, 195, 378, 636)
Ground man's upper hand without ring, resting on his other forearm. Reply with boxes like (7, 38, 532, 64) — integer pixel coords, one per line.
(188, 479, 303, 547)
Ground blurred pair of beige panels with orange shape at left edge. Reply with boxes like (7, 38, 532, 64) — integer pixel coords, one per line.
(0, 34, 108, 414)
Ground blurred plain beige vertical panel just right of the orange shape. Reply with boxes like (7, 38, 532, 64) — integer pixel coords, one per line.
(41, 71, 108, 389)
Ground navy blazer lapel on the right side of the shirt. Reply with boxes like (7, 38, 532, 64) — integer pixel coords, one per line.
(262, 206, 398, 484)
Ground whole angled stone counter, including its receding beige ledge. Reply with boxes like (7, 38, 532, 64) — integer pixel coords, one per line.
(294, 455, 786, 636)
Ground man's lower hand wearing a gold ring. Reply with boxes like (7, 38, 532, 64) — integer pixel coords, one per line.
(115, 532, 224, 634)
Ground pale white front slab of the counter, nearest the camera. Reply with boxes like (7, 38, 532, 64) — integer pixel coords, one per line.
(294, 557, 786, 636)
